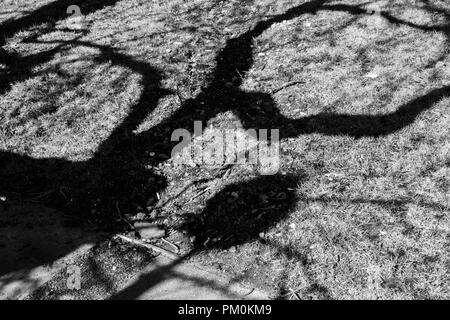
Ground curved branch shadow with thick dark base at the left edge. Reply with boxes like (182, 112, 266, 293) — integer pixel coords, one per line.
(0, 43, 169, 216)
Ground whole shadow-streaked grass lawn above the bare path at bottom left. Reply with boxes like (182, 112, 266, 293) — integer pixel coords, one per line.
(0, 0, 450, 299)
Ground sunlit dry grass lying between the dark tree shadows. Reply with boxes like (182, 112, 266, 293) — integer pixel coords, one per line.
(0, 0, 450, 299)
